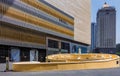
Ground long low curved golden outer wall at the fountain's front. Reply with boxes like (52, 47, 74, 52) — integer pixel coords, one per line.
(13, 59, 119, 71)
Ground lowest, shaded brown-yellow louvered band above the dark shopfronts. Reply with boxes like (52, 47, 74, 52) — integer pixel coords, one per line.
(0, 22, 46, 45)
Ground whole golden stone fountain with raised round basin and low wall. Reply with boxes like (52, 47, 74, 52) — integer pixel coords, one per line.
(13, 54, 120, 71)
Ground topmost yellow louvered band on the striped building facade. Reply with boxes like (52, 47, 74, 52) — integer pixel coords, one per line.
(21, 0, 74, 25)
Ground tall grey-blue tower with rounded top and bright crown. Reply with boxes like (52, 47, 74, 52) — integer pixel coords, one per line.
(96, 3, 116, 53)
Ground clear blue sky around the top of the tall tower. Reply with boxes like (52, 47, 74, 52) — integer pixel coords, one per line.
(91, 0, 120, 43)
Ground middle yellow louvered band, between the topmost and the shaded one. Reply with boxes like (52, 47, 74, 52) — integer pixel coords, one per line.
(0, 4, 74, 36)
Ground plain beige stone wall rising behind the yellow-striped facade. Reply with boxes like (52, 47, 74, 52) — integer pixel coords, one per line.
(45, 0, 91, 44)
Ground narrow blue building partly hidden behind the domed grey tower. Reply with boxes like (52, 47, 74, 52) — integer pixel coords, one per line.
(91, 23, 97, 52)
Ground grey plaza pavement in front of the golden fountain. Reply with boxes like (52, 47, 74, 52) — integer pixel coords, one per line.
(0, 63, 120, 76)
